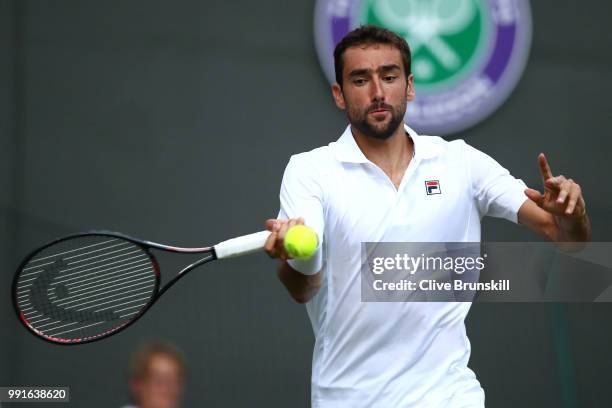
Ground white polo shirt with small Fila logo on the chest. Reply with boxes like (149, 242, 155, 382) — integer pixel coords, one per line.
(279, 126, 526, 408)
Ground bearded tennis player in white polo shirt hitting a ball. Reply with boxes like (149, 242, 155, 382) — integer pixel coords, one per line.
(266, 26, 590, 408)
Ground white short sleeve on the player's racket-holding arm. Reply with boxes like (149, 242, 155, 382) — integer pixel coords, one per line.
(278, 154, 325, 275)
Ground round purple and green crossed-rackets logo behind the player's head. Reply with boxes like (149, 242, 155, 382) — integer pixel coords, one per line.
(315, 0, 531, 135)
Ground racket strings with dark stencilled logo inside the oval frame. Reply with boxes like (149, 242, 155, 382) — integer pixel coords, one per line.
(16, 235, 158, 341)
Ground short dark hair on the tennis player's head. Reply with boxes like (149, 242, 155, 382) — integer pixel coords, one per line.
(334, 24, 412, 87)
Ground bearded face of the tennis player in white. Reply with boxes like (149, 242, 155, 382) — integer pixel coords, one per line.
(332, 44, 414, 140)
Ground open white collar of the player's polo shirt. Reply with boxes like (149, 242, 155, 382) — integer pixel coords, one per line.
(330, 124, 439, 163)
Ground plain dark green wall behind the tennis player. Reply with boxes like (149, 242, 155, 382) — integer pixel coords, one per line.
(0, 0, 612, 407)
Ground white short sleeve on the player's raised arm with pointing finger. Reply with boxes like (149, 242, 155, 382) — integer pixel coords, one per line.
(465, 144, 527, 223)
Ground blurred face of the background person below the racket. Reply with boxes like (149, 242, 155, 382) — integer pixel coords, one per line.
(131, 354, 183, 408)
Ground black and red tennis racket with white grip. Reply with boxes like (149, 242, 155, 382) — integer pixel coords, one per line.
(13, 231, 270, 344)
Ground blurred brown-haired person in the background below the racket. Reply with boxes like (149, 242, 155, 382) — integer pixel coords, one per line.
(120, 342, 185, 408)
